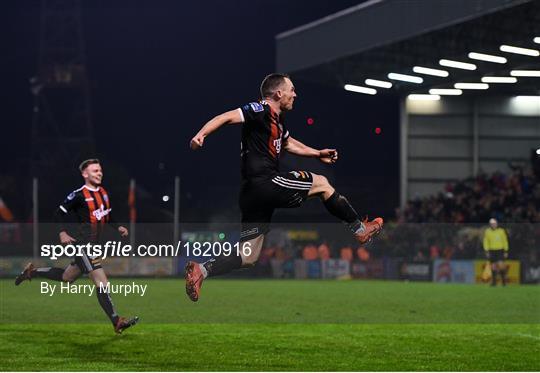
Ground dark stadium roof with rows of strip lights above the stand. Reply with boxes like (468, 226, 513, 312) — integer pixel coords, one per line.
(276, 0, 540, 95)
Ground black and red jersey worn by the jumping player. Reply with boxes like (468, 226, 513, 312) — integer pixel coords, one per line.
(238, 101, 289, 179)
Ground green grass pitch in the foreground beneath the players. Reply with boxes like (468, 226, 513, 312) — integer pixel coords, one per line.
(0, 279, 540, 371)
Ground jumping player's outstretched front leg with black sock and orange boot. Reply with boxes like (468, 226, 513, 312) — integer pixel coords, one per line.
(308, 173, 383, 243)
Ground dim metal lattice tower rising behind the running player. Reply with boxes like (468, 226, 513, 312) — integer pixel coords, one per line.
(30, 0, 94, 176)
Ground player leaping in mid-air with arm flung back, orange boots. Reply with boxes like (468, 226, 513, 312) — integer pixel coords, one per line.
(185, 73, 383, 301)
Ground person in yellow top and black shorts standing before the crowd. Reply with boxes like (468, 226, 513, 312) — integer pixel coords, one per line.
(484, 218, 508, 286)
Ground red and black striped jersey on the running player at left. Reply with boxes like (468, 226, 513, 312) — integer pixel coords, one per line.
(56, 185, 116, 242)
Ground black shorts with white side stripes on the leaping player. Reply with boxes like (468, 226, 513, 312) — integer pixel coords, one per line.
(240, 171, 313, 241)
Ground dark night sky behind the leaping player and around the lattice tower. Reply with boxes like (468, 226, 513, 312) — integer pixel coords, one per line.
(4, 0, 399, 220)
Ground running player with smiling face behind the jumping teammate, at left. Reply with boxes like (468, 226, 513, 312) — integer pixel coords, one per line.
(15, 159, 139, 334)
